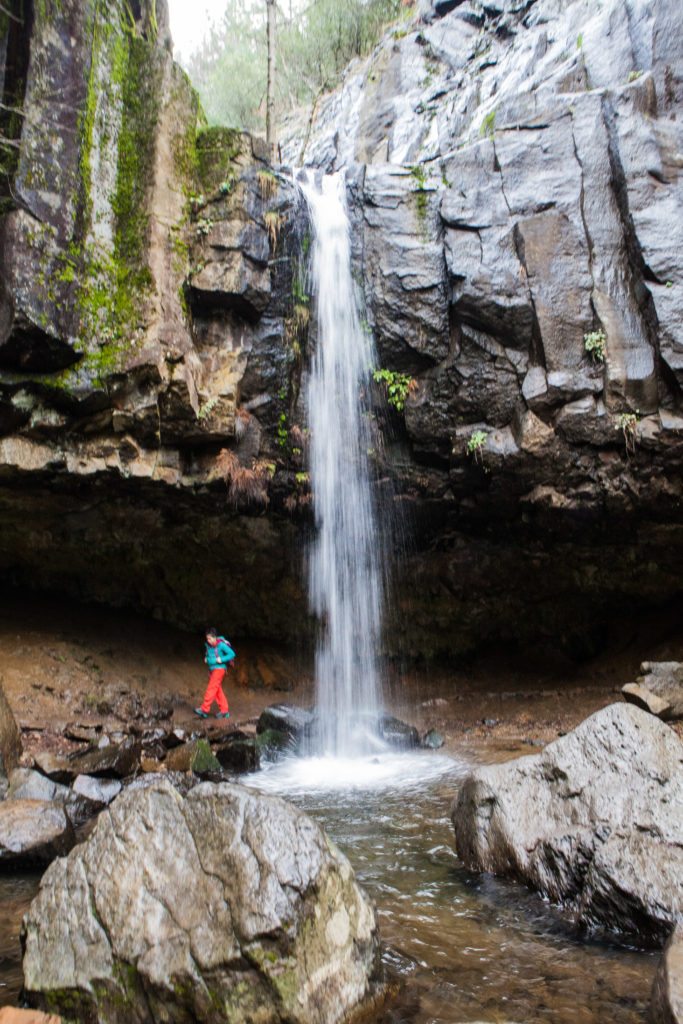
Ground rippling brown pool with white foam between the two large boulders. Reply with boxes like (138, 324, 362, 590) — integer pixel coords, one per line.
(245, 754, 656, 1024)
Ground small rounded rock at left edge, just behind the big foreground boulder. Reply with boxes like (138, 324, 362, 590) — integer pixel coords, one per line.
(0, 800, 76, 867)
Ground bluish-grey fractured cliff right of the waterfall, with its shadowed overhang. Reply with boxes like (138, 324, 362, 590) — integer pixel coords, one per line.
(286, 0, 683, 649)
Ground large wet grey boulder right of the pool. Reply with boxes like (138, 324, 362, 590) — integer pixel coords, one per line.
(453, 703, 683, 943)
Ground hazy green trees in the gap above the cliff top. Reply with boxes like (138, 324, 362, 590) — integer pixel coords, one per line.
(187, 0, 409, 132)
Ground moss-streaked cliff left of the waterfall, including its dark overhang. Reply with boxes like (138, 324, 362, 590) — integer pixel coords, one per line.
(0, 0, 307, 637)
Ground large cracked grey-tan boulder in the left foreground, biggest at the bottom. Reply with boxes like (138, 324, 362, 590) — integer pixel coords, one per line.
(23, 782, 380, 1024)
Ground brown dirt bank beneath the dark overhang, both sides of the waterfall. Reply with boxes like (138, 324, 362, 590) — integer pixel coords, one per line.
(0, 593, 683, 756)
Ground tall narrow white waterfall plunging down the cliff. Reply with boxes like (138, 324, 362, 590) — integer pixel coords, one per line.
(300, 173, 383, 756)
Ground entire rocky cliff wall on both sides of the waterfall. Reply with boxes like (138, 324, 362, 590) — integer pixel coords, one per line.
(0, 0, 683, 655)
